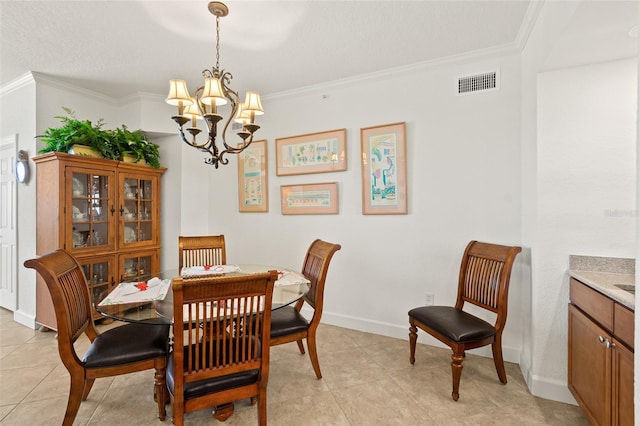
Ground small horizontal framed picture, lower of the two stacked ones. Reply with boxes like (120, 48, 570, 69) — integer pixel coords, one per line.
(280, 182, 338, 214)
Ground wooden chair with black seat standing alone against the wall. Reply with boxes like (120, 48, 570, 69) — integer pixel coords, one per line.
(409, 241, 521, 401)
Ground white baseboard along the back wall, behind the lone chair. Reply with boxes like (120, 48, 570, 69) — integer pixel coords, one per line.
(318, 309, 520, 364)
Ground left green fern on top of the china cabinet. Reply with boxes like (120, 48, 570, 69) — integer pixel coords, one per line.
(36, 107, 120, 160)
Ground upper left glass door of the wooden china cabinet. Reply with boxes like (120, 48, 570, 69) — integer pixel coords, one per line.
(67, 169, 114, 252)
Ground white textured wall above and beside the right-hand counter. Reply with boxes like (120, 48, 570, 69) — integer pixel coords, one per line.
(532, 59, 638, 402)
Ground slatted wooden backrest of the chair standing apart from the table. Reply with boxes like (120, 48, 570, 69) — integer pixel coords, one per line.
(456, 241, 521, 327)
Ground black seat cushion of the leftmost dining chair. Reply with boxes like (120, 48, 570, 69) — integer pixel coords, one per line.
(82, 324, 169, 368)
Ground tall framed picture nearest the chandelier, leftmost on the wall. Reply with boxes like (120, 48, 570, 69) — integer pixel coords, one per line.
(238, 140, 269, 212)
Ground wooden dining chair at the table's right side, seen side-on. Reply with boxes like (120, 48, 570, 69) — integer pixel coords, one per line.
(271, 239, 342, 379)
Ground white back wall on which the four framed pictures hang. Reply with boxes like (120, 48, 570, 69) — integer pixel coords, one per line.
(184, 56, 523, 362)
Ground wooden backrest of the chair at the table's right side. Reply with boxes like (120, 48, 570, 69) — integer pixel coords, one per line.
(302, 239, 342, 312)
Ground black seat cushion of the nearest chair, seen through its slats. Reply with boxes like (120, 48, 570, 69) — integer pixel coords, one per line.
(167, 341, 261, 400)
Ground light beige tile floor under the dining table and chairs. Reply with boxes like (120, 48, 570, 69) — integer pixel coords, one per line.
(0, 309, 589, 426)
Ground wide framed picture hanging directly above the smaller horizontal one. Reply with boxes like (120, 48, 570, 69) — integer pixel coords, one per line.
(276, 129, 347, 176)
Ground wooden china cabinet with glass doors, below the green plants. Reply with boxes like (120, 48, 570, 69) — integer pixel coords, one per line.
(33, 152, 166, 330)
